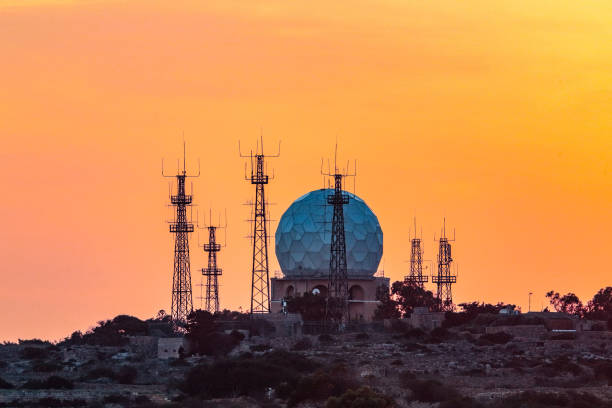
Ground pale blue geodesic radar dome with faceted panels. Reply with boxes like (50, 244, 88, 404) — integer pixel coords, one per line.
(275, 189, 383, 278)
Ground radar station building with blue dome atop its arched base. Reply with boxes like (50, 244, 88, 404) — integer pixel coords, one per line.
(270, 189, 389, 321)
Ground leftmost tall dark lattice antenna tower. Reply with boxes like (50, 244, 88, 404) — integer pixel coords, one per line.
(162, 142, 200, 324)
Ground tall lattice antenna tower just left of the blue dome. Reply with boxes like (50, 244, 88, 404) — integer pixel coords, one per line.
(238, 135, 280, 317)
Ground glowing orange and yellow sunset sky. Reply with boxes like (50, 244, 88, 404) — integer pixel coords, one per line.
(0, 0, 612, 341)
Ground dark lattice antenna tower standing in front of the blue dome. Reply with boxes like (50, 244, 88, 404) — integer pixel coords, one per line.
(321, 143, 357, 325)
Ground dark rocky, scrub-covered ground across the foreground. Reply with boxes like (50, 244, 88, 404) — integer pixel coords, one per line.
(0, 329, 612, 407)
